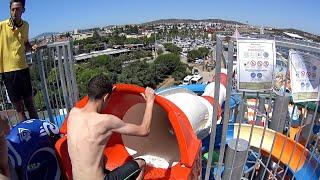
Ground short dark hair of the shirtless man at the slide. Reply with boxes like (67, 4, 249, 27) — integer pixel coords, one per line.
(88, 74, 112, 100)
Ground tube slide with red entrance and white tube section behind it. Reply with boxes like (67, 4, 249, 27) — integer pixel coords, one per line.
(56, 70, 229, 179)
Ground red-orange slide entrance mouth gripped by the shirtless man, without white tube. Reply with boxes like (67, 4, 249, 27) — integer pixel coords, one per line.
(56, 84, 201, 179)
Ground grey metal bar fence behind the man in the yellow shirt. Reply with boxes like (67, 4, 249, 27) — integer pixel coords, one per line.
(0, 41, 79, 125)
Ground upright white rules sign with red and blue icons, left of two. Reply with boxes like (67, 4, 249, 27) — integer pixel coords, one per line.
(237, 39, 276, 92)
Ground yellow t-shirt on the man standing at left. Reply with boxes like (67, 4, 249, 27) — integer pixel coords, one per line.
(0, 19, 29, 73)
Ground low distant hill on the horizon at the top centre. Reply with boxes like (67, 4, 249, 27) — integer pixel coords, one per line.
(143, 19, 244, 25)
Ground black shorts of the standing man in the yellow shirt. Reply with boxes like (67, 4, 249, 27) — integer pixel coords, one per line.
(2, 68, 32, 102)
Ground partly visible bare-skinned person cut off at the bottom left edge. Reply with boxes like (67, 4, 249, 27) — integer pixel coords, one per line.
(0, 116, 10, 180)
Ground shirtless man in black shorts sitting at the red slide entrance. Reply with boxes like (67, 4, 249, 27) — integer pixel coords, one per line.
(67, 75, 155, 180)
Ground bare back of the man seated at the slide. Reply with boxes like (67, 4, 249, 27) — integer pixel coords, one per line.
(68, 108, 112, 180)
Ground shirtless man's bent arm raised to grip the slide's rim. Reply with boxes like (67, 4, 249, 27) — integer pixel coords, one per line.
(110, 87, 154, 136)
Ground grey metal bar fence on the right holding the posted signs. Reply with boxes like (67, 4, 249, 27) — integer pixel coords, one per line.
(202, 36, 320, 180)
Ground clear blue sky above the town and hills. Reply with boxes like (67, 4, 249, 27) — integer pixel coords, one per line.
(0, 0, 320, 37)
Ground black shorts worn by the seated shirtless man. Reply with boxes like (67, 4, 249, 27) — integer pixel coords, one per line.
(104, 160, 141, 180)
